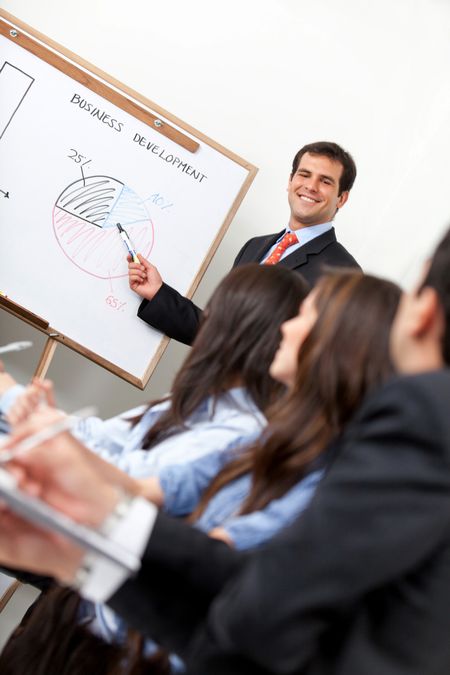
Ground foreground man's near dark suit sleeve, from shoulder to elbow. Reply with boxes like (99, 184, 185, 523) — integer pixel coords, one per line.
(188, 381, 450, 675)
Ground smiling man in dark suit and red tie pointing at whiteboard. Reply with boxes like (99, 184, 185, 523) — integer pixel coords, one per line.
(129, 142, 359, 344)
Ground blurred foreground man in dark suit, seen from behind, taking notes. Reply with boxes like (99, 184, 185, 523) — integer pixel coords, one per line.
(0, 232, 450, 675)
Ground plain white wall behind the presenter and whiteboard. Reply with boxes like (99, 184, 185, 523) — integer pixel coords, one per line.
(0, 0, 450, 415)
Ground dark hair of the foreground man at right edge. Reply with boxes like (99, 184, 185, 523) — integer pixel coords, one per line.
(422, 229, 450, 365)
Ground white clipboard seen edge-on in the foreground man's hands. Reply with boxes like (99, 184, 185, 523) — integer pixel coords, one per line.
(0, 469, 141, 574)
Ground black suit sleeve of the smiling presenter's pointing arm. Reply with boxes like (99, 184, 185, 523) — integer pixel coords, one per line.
(138, 283, 202, 345)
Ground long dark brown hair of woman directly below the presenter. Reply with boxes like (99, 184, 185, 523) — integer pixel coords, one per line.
(142, 263, 309, 448)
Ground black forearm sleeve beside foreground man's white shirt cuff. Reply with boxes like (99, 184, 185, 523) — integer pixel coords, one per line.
(108, 513, 246, 655)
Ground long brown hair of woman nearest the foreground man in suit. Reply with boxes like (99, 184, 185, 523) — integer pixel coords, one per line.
(190, 271, 401, 521)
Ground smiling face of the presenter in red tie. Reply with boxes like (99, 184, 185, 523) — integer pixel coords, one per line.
(288, 152, 348, 230)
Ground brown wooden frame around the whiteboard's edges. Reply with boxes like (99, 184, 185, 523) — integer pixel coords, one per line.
(0, 9, 258, 389)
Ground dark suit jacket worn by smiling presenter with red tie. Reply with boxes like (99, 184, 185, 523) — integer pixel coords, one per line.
(138, 227, 359, 345)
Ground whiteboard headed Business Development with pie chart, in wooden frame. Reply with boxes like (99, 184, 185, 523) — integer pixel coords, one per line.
(0, 11, 257, 387)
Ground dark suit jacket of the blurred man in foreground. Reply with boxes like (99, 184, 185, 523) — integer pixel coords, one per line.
(112, 370, 450, 675)
